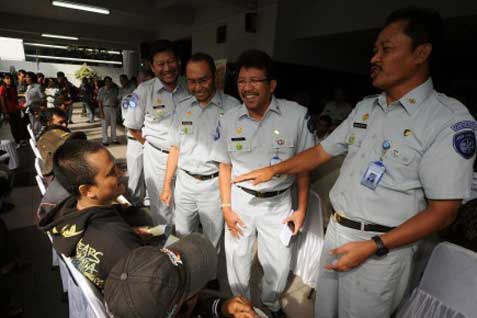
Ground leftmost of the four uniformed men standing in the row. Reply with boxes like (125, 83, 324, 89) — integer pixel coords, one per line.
(124, 40, 188, 224)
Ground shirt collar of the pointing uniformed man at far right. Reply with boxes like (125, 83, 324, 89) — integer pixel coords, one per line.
(375, 77, 434, 116)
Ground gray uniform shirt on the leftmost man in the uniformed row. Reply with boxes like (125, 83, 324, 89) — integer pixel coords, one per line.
(124, 77, 189, 149)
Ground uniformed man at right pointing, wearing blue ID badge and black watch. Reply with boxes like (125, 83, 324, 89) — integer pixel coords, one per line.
(235, 8, 477, 318)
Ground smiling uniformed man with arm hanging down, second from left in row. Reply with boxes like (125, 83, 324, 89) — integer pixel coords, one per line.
(161, 53, 240, 248)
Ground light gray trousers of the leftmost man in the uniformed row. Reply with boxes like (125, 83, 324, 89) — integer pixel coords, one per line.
(143, 142, 175, 225)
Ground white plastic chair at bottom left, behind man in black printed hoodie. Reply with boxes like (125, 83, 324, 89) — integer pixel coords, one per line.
(61, 254, 109, 318)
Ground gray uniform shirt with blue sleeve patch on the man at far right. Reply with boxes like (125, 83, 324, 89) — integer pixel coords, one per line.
(321, 79, 476, 226)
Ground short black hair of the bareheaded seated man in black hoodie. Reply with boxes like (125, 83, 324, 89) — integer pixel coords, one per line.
(53, 139, 106, 198)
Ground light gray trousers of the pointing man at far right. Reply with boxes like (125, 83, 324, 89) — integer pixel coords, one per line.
(315, 218, 416, 318)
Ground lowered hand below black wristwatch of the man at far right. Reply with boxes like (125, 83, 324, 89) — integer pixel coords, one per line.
(325, 240, 377, 272)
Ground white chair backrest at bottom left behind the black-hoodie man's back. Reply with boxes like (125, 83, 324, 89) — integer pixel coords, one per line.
(61, 254, 109, 318)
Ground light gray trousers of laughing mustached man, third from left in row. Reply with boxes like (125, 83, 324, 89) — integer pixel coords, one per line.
(225, 186, 292, 311)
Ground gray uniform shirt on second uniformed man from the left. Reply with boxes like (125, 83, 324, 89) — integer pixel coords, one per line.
(172, 91, 240, 175)
